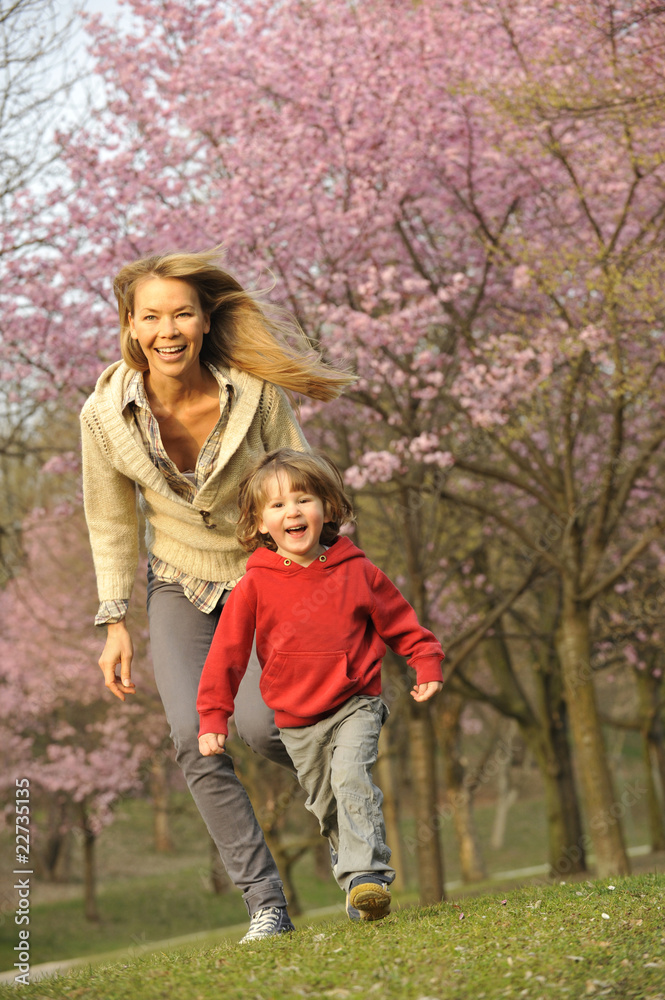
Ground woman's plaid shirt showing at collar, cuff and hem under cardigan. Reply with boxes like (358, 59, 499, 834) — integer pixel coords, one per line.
(95, 362, 233, 625)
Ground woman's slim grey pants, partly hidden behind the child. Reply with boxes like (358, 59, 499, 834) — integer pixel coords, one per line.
(148, 573, 293, 916)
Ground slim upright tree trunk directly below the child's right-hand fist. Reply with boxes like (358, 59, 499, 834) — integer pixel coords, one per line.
(408, 702, 444, 906)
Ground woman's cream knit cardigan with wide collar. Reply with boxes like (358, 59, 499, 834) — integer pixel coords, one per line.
(81, 361, 308, 601)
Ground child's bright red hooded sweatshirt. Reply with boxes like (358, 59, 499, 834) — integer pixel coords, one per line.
(197, 537, 443, 735)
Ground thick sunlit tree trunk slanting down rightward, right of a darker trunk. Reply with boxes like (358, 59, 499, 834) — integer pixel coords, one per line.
(556, 584, 630, 878)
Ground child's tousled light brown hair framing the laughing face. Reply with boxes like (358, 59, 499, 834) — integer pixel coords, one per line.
(236, 448, 354, 552)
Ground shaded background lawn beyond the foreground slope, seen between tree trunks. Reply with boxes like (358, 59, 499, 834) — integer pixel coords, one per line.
(0, 760, 647, 969)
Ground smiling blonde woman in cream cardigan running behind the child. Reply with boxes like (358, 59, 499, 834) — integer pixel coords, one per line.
(81, 250, 353, 941)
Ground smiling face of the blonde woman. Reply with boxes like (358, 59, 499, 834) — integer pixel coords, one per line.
(129, 278, 210, 379)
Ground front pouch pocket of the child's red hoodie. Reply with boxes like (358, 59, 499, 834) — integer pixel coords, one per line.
(261, 650, 359, 718)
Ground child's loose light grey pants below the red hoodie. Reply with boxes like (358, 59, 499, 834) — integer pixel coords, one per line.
(279, 695, 395, 892)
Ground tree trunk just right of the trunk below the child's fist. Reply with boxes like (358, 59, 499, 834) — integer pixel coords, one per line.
(439, 694, 487, 882)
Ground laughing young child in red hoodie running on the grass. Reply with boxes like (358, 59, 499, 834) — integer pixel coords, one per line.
(197, 449, 443, 920)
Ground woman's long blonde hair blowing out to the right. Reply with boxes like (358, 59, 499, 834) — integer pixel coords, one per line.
(113, 248, 356, 400)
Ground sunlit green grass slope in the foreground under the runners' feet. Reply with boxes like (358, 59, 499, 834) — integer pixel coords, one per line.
(0, 875, 665, 1000)
